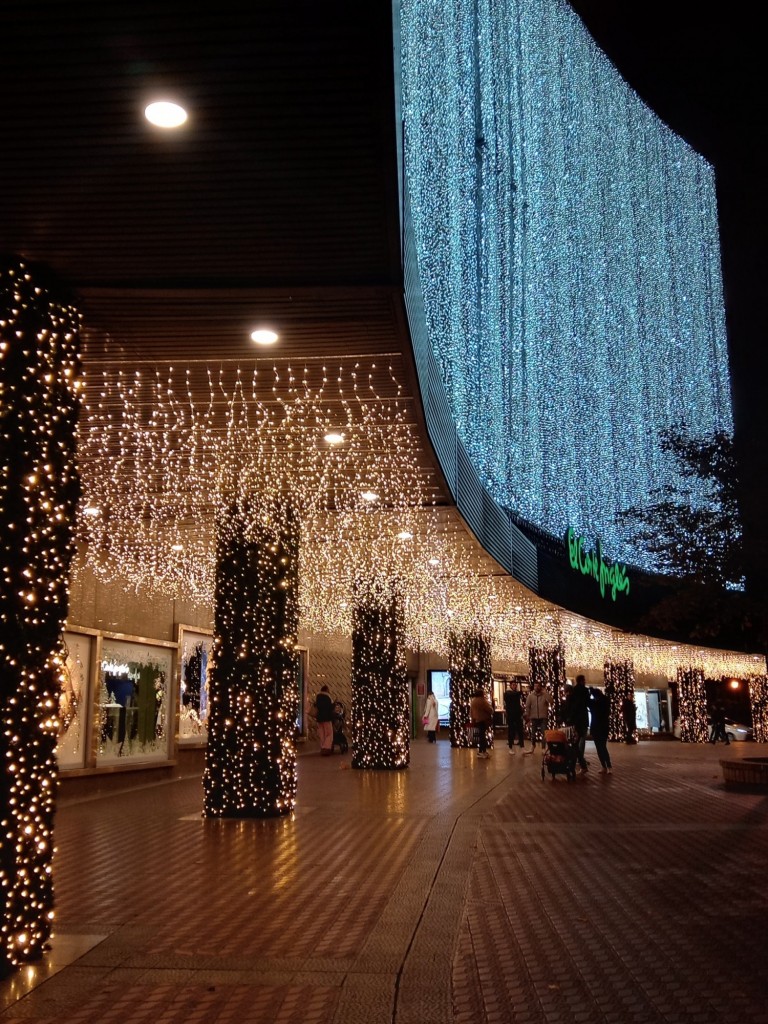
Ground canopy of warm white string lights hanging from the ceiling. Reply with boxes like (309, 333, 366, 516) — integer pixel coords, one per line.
(72, 358, 764, 720)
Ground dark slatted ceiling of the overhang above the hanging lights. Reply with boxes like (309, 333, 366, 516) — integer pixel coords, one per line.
(0, 0, 512, 571)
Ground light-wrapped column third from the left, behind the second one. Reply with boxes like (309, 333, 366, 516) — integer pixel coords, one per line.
(352, 586, 411, 769)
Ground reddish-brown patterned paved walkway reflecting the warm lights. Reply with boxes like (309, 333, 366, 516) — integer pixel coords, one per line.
(0, 737, 768, 1024)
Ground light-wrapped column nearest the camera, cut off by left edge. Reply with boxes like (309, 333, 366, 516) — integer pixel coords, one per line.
(0, 251, 81, 973)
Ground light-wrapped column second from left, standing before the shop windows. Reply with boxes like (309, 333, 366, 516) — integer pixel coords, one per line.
(203, 508, 299, 818)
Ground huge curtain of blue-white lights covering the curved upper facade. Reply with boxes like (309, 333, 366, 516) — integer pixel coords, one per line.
(401, 0, 732, 568)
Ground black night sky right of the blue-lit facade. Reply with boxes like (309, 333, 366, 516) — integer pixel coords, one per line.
(569, 0, 768, 589)
